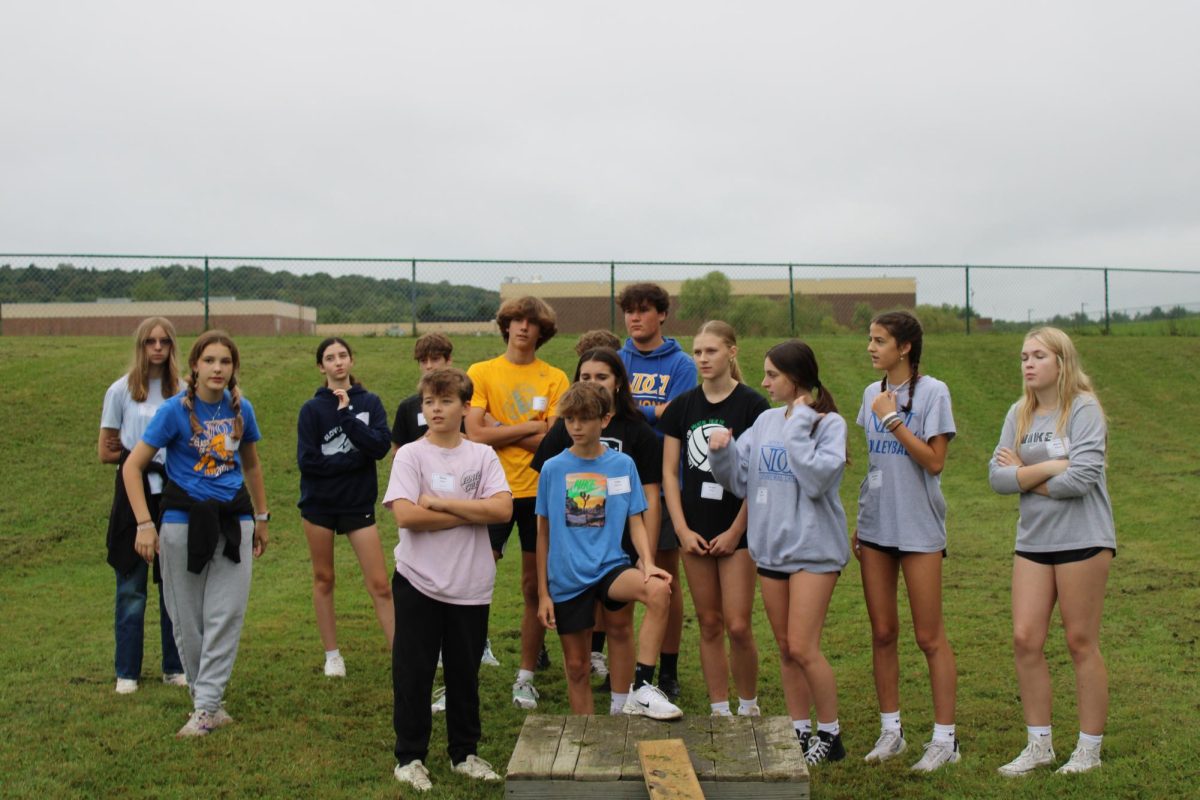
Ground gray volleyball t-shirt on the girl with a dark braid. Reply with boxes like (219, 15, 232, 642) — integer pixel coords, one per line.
(857, 375, 955, 553)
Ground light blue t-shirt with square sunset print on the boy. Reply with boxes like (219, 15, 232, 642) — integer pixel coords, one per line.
(536, 450, 646, 603)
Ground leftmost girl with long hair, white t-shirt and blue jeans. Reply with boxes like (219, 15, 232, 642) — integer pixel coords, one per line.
(96, 317, 187, 694)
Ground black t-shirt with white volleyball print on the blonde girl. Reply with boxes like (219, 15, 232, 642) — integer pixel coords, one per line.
(659, 384, 770, 539)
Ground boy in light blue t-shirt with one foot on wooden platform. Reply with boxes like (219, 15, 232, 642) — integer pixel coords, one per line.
(536, 381, 683, 720)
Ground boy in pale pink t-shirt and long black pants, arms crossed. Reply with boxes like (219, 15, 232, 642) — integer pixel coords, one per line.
(383, 368, 512, 792)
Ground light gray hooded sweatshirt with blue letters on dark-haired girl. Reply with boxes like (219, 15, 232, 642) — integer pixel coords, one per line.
(708, 405, 850, 573)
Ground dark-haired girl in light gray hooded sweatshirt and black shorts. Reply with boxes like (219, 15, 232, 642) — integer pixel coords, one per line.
(709, 339, 850, 764)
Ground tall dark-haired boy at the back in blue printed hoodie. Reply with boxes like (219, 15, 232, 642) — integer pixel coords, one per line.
(617, 283, 696, 699)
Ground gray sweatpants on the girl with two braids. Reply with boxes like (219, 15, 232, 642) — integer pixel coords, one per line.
(158, 521, 254, 711)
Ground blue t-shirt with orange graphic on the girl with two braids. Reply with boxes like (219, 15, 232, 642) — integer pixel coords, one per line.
(142, 391, 263, 522)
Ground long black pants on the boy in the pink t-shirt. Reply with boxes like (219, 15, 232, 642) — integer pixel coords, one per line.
(391, 572, 490, 765)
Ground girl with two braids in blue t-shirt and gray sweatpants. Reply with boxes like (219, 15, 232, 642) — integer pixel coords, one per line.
(122, 331, 271, 736)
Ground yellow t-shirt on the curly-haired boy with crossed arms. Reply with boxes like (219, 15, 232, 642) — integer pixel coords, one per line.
(467, 355, 570, 498)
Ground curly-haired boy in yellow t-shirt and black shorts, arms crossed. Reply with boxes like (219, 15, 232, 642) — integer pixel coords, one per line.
(467, 297, 568, 709)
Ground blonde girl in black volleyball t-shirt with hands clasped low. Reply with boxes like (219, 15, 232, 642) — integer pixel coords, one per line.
(659, 320, 770, 716)
